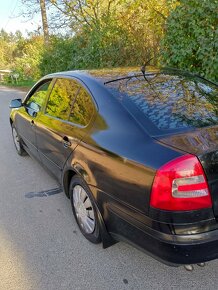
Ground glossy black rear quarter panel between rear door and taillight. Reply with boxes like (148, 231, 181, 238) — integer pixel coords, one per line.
(62, 77, 182, 215)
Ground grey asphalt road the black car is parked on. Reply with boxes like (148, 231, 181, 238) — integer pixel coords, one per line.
(0, 87, 218, 290)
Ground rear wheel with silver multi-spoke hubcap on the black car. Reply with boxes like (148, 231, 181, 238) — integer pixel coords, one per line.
(70, 175, 101, 244)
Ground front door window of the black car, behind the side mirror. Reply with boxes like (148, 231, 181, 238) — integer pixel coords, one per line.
(26, 80, 51, 110)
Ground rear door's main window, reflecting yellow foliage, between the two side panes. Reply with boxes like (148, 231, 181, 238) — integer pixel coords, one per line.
(46, 79, 80, 120)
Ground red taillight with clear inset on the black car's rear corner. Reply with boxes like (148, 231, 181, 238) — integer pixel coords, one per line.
(150, 154, 212, 211)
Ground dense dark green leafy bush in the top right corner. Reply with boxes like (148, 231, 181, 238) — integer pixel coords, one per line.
(161, 0, 218, 80)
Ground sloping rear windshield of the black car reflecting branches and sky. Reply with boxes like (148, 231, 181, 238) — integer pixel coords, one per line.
(106, 73, 218, 130)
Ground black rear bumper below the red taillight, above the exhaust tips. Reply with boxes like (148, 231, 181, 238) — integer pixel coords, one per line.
(107, 206, 218, 266)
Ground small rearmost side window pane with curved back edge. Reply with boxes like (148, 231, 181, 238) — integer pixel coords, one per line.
(69, 87, 94, 126)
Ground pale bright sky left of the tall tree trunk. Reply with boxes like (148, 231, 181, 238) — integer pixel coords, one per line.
(0, 0, 41, 35)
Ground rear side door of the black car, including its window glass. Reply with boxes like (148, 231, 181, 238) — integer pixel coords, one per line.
(37, 78, 94, 179)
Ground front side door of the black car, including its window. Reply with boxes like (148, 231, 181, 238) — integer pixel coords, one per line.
(15, 79, 52, 158)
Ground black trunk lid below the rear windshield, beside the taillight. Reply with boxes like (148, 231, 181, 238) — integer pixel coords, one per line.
(156, 126, 218, 218)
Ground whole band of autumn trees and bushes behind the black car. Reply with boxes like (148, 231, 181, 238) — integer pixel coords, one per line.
(0, 0, 218, 85)
